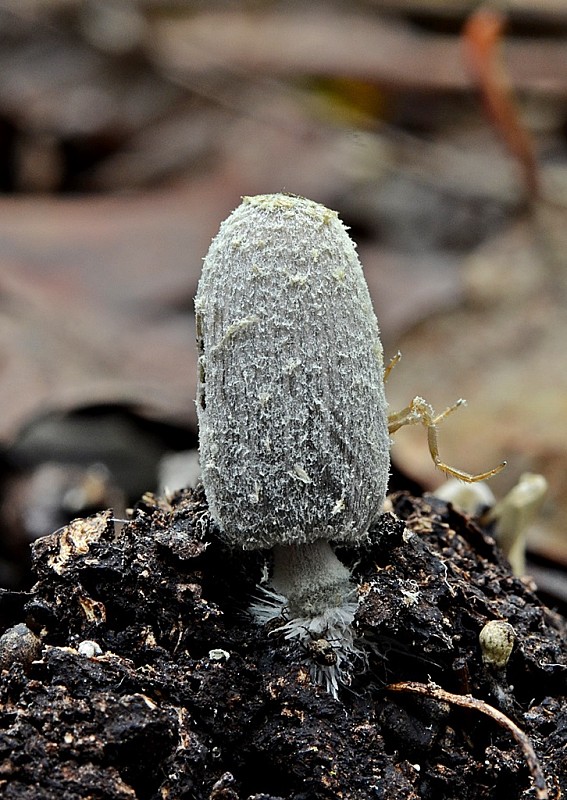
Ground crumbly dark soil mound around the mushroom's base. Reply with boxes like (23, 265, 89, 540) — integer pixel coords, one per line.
(0, 484, 567, 800)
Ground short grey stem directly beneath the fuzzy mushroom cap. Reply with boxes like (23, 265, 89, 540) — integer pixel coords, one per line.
(272, 539, 353, 617)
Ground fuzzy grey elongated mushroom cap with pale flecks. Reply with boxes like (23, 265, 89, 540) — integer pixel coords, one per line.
(195, 194, 390, 549)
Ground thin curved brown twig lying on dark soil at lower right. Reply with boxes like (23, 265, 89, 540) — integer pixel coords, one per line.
(386, 681, 549, 800)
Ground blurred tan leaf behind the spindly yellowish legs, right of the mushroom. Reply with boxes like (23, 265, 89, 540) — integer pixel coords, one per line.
(387, 208, 567, 563)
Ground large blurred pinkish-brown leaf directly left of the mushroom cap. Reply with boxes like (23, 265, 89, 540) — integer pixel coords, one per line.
(0, 179, 235, 440)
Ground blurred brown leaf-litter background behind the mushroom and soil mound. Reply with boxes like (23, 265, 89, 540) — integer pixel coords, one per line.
(0, 0, 567, 604)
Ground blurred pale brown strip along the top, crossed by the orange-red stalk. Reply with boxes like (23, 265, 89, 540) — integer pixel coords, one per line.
(149, 5, 567, 95)
